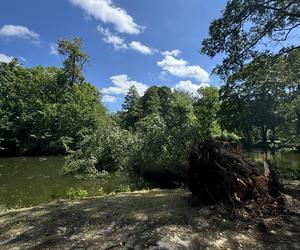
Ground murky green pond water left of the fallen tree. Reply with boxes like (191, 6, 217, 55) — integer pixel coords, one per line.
(0, 157, 121, 207)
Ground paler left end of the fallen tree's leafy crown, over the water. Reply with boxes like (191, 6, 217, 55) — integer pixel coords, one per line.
(64, 126, 140, 177)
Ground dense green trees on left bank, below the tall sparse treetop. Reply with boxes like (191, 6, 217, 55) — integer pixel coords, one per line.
(0, 40, 109, 155)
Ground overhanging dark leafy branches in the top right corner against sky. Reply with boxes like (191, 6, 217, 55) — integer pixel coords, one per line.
(201, 0, 300, 78)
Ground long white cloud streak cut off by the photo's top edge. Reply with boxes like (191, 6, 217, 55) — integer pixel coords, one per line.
(69, 0, 144, 34)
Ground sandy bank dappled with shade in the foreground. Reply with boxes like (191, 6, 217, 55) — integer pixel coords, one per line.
(0, 187, 300, 250)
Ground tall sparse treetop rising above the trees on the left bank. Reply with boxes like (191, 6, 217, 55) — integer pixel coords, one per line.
(58, 37, 89, 86)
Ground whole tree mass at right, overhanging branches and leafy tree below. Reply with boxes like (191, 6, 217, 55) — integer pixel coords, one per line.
(201, 0, 300, 146)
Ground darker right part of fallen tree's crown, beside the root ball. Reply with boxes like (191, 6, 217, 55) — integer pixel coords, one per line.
(133, 120, 196, 181)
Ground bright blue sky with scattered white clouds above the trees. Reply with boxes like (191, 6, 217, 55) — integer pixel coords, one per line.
(0, 0, 227, 111)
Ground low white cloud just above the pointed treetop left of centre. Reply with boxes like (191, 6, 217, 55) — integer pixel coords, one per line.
(102, 74, 148, 95)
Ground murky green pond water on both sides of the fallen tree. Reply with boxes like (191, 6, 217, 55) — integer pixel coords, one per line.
(0, 151, 300, 208)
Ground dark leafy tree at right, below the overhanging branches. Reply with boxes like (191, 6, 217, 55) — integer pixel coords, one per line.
(219, 51, 299, 145)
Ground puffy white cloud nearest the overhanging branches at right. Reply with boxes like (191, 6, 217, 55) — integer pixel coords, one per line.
(157, 52, 209, 82)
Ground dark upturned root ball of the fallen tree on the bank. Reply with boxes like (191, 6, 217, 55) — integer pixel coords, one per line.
(188, 141, 281, 213)
